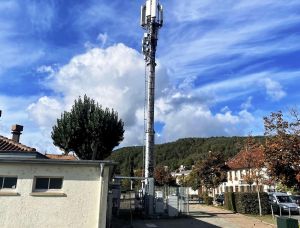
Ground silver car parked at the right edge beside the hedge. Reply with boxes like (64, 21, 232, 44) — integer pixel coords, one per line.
(269, 192, 300, 213)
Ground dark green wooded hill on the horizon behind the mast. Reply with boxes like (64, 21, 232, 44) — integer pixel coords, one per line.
(107, 136, 264, 175)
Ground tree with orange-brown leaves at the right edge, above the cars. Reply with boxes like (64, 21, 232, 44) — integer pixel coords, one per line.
(264, 110, 300, 190)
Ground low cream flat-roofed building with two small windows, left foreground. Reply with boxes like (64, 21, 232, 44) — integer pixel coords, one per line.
(0, 158, 115, 228)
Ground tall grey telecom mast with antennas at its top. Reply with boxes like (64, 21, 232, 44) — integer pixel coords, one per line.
(141, 0, 163, 215)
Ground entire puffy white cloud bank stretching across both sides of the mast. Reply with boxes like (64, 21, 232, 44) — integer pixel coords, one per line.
(27, 44, 260, 151)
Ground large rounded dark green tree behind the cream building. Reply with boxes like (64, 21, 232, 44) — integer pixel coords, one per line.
(51, 95, 124, 160)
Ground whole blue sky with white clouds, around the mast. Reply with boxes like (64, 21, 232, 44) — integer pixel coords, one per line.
(0, 0, 300, 152)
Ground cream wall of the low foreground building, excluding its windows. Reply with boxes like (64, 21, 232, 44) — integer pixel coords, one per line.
(0, 164, 109, 228)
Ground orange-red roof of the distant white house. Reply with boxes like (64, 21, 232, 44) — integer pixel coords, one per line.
(227, 147, 264, 169)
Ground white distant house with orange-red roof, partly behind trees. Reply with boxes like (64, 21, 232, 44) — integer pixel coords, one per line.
(215, 149, 275, 194)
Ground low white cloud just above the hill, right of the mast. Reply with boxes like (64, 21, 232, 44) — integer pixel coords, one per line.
(158, 104, 254, 141)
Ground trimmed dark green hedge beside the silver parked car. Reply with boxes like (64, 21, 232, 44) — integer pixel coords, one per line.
(234, 192, 270, 215)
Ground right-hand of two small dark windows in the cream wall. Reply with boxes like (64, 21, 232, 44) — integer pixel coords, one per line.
(34, 177, 63, 191)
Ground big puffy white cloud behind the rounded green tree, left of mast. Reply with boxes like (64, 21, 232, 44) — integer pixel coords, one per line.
(28, 44, 168, 145)
